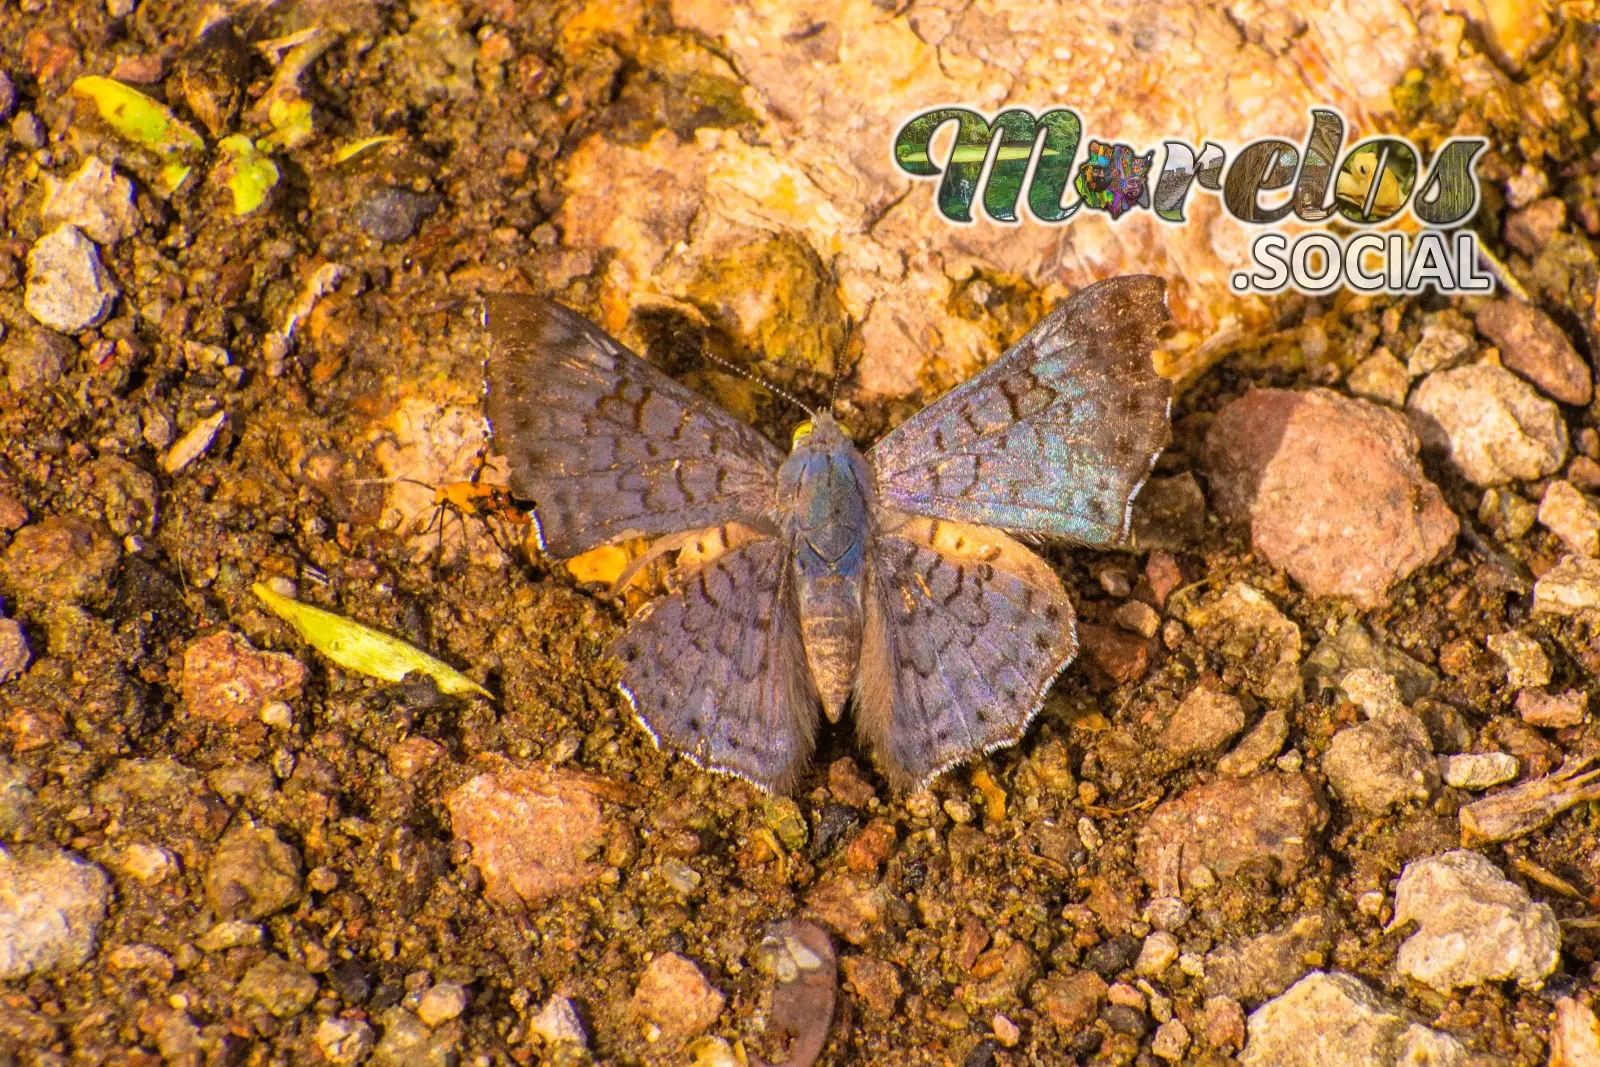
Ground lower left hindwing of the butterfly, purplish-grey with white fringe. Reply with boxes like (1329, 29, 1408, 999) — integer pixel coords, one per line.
(611, 537, 819, 792)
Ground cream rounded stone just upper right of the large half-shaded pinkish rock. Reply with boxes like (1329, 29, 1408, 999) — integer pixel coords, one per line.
(1406, 363, 1566, 486)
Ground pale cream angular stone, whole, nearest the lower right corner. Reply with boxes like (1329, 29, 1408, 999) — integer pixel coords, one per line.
(1389, 849, 1562, 993)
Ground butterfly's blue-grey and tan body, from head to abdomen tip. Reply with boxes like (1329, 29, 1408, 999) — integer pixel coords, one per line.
(778, 414, 872, 721)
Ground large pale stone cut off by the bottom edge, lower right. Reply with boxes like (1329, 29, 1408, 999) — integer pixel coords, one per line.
(1238, 971, 1467, 1067)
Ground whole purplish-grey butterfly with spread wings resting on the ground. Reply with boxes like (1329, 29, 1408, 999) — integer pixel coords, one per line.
(485, 275, 1171, 792)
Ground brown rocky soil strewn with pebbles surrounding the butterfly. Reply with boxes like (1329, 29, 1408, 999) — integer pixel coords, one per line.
(0, 0, 1600, 1067)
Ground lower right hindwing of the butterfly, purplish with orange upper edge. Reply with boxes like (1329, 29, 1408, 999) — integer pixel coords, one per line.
(856, 517, 1078, 785)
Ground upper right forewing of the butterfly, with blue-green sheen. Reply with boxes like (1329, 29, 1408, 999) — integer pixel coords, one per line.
(870, 275, 1173, 545)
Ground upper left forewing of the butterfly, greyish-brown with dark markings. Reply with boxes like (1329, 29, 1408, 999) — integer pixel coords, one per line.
(483, 293, 782, 558)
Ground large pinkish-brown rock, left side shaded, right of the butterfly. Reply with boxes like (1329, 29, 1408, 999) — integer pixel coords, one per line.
(1203, 389, 1459, 605)
